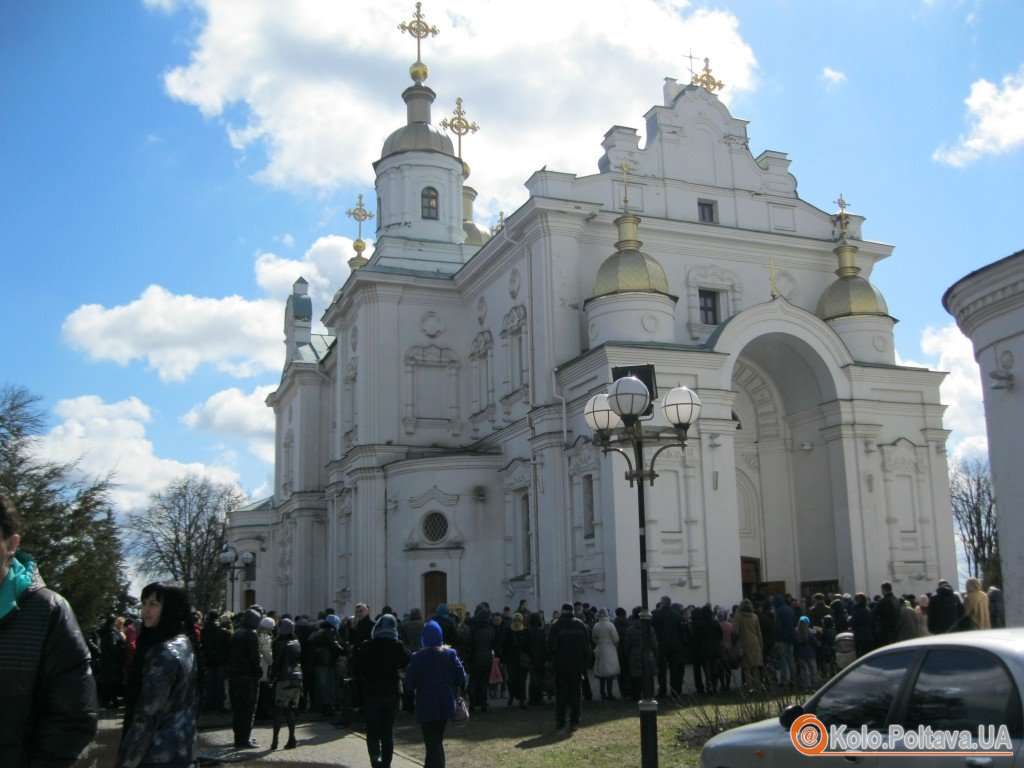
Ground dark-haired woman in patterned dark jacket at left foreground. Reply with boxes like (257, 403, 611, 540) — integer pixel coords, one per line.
(116, 583, 199, 768)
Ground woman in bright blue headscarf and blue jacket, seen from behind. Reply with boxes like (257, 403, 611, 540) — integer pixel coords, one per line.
(406, 621, 466, 768)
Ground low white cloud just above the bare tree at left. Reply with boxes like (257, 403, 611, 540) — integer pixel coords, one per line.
(38, 395, 239, 512)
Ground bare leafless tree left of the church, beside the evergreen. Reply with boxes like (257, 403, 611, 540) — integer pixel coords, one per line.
(126, 475, 248, 611)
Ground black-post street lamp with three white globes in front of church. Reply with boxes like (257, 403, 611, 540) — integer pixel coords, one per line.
(584, 374, 700, 768)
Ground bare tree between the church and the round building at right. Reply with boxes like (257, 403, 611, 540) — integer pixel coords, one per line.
(949, 459, 1002, 588)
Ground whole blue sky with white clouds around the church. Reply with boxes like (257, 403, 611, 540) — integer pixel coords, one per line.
(0, 0, 1024, 518)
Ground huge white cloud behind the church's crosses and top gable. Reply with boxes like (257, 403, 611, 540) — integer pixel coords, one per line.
(155, 0, 756, 214)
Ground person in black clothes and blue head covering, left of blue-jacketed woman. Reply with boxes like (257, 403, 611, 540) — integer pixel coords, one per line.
(353, 613, 409, 768)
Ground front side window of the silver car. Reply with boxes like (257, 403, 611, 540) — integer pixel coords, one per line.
(813, 650, 915, 728)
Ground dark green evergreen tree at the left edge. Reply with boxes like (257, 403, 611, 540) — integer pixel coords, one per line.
(0, 384, 127, 627)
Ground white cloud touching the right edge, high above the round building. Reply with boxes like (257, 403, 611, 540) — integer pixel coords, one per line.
(932, 66, 1024, 168)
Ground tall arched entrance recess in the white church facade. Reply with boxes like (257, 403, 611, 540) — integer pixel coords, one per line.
(731, 325, 848, 596)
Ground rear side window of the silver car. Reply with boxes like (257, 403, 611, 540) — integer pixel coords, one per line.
(904, 648, 1022, 738)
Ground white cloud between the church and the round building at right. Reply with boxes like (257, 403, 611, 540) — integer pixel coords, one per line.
(898, 323, 988, 459)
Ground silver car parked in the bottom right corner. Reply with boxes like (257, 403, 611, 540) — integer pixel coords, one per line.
(700, 629, 1024, 768)
